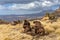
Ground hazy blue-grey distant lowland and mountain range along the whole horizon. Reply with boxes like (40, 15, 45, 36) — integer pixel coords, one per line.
(0, 10, 54, 21)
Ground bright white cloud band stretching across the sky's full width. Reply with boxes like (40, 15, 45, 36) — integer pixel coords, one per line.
(0, 0, 59, 10)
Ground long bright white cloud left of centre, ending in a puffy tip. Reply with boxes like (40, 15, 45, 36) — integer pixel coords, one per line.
(8, 3, 35, 10)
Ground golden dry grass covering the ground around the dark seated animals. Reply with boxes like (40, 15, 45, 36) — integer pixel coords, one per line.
(0, 17, 60, 40)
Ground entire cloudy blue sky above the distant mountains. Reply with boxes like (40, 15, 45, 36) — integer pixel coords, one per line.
(0, 0, 60, 15)
